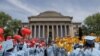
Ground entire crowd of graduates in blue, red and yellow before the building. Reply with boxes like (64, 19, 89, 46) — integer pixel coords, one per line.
(0, 27, 100, 56)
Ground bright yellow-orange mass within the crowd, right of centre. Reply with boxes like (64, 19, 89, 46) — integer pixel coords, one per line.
(55, 34, 100, 52)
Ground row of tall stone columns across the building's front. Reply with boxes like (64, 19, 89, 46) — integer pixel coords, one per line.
(30, 24, 74, 38)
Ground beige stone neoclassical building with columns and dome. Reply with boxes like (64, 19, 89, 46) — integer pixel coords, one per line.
(23, 11, 81, 40)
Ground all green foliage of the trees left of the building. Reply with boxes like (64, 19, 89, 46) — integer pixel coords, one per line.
(0, 12, 21, 37)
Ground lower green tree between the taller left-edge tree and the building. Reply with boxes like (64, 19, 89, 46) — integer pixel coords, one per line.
(5, 19, 21, 36)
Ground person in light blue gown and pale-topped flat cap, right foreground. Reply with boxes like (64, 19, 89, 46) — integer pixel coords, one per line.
(84, 36, 100, 56)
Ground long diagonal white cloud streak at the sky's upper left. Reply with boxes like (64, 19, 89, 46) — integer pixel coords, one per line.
(7, 0, 38, 15)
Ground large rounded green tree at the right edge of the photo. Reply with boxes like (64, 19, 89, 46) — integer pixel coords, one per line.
(84, 13, 100, 35)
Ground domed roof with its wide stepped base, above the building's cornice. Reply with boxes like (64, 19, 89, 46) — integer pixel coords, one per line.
(29, 11, 72, 19)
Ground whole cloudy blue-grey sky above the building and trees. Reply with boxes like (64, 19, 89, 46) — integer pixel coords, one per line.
(0, 0, 100, 22)
